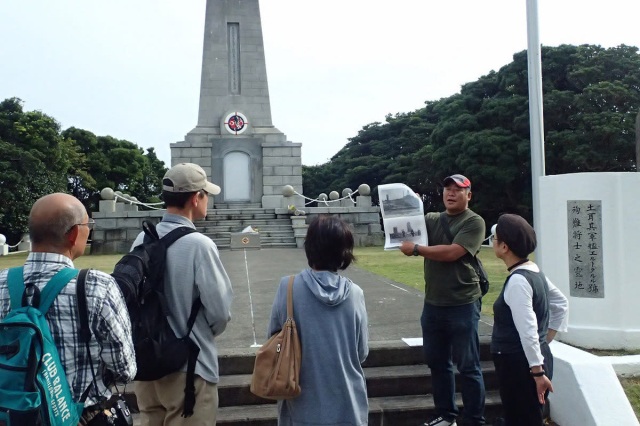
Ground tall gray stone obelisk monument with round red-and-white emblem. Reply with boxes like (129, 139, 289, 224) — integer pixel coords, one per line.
(171, 0, 304, 208)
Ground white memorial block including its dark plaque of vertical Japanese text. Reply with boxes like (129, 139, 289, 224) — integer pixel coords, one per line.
(536, 172, 640, 349)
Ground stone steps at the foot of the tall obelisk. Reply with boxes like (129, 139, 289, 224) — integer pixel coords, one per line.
(195, 204, 296, 250)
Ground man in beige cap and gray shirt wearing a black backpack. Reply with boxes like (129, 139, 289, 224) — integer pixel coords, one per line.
(132, 163, 233, 426)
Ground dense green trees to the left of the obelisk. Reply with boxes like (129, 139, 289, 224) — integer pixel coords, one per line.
(0, 98, 166, 244)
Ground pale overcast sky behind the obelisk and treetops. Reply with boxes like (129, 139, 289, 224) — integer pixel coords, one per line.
(0, 0, 640, 166)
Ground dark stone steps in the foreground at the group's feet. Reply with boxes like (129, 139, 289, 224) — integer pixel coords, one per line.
(129, 336, 501, 426)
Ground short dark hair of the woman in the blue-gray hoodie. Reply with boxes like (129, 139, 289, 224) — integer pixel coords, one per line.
(304, 215, 355, 272)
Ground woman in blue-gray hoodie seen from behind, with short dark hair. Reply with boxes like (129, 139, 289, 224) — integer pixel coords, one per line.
(268, 216, 369, 426)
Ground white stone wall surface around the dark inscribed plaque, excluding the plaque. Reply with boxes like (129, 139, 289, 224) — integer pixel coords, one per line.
(535, 173, 640, 349)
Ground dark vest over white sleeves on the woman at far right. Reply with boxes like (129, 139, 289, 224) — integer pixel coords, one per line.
(491, 269, 549, 354)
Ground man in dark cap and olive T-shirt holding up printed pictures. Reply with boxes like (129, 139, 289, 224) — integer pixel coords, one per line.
(400, 174, 485, 426)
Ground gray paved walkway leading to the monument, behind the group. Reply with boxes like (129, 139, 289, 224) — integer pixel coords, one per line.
(216, 248, 493, 351)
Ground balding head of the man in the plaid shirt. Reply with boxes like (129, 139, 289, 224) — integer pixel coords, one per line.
(29, 193, 87, 251)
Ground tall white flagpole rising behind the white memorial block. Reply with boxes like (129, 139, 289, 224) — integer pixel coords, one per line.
(527, 0, 545, 267)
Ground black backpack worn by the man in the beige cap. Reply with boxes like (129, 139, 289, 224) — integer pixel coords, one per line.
(111, 220, 201, 417)
